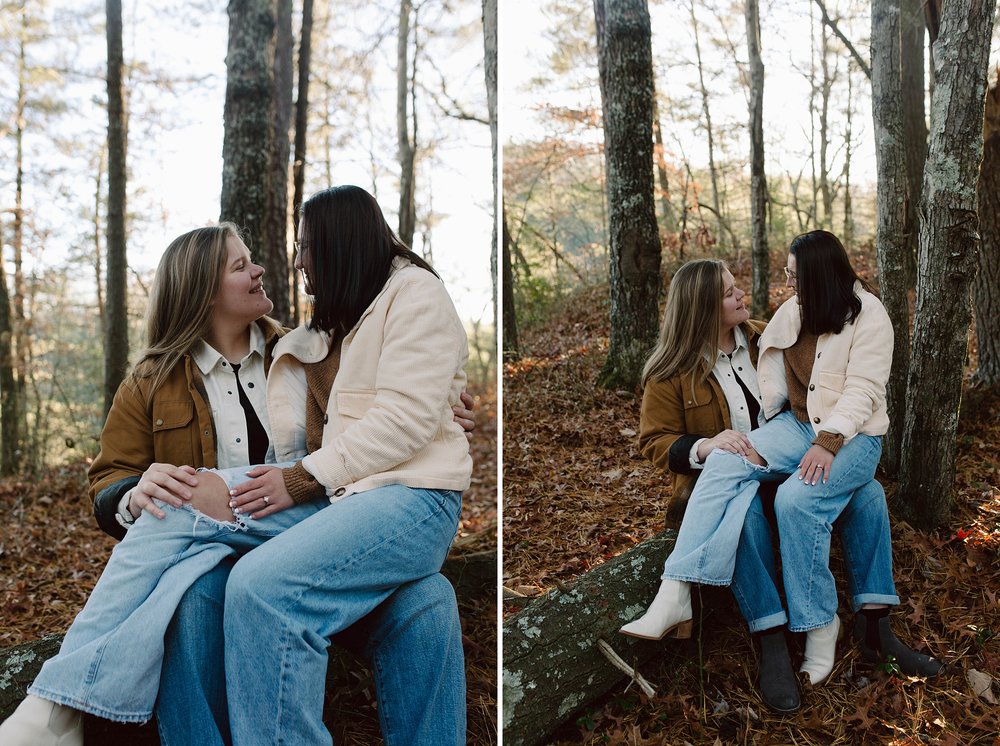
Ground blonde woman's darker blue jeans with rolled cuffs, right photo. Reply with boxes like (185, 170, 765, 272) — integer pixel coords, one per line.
(732, 480, 899, 632)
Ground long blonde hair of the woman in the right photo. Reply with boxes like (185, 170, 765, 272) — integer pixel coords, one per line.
(642, 259, 727, 386)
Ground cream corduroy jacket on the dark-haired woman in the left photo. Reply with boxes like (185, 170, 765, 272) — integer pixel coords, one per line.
(267, 258, 472, 501)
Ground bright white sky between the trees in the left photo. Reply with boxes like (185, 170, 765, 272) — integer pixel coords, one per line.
(18, 0, 493, 323)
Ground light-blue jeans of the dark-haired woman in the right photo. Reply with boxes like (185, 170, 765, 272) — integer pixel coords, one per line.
(662, 412, 882, 604)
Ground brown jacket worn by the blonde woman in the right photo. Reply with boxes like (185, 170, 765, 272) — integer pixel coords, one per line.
(639, 319, 766, 523)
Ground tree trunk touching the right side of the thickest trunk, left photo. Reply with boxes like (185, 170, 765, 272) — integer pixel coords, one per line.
(261, 0, 294, 326)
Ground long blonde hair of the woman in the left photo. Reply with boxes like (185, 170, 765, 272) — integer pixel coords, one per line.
(135, 223, 242, 393)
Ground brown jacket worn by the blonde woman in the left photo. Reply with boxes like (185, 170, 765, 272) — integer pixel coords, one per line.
(87, 317, 286, 539)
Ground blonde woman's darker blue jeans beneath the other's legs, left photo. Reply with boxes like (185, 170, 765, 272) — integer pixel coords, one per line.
(156, 561, 466, 746)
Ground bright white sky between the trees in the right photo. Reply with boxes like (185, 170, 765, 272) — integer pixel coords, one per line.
(503, 0, 875, 184)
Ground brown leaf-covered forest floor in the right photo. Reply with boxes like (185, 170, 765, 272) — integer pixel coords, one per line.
(503, 251, 1000, 746)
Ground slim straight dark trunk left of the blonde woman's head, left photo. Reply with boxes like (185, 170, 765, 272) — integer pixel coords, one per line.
(104, 0, 128, 417)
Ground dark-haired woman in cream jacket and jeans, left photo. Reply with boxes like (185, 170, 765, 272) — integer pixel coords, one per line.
(218, 186, 471, 744)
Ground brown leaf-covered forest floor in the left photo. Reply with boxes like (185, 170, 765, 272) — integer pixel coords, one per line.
(0, 380, 497, 746)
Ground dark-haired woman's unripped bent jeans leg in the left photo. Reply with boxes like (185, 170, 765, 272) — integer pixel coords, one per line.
(225, 485, 465, 746)
